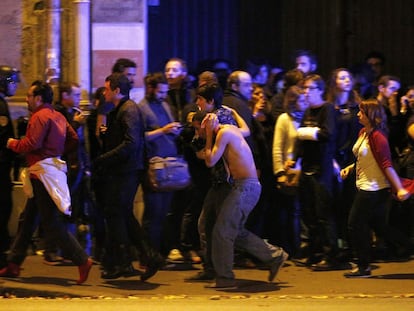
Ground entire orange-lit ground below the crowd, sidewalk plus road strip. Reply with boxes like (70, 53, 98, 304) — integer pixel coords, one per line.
(0, 255, 414, 311)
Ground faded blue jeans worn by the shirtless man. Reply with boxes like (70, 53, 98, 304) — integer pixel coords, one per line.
(212, 178, 273, 279)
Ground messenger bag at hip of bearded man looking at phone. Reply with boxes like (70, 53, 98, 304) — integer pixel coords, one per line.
(148, 157, 191, 191)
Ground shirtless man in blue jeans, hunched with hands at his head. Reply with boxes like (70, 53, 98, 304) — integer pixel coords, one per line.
(193, 112, 288, 289)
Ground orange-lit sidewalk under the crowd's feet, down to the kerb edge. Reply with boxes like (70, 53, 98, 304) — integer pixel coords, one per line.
(0, 255, 414, 301)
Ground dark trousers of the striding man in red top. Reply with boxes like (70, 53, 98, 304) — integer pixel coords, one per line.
(8, 179, 88, 266)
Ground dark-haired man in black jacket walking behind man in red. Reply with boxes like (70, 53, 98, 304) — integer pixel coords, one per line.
(94, 73, 163, 281)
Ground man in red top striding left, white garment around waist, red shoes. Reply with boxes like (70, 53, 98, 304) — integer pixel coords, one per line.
(0, 80, 92, 284)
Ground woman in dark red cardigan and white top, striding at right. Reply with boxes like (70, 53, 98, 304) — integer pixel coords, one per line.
(341, 100, 411, 278)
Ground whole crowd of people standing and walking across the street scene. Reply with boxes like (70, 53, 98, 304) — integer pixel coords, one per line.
(0, 50, 414, 289)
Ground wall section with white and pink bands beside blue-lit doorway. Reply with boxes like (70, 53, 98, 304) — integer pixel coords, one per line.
(92, 0, 146, 100)
